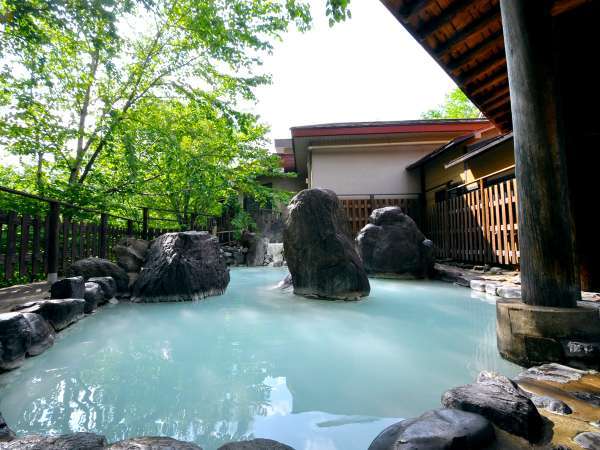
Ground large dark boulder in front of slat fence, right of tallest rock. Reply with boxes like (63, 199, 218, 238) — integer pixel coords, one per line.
(356, 206, 434, 277)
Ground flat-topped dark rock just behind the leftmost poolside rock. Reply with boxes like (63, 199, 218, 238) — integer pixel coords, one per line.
(14, 298, 85, 331)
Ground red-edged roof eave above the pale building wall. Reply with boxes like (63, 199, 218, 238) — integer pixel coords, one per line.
(291, 119, 490, 138)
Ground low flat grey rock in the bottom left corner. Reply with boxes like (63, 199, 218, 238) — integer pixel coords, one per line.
(0, 433, 106, 450)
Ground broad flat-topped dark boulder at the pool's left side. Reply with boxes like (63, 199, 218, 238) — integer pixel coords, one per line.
(132, 231, 229, 302)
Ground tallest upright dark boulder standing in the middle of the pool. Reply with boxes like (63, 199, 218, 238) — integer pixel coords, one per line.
(283, 189, 370, 300)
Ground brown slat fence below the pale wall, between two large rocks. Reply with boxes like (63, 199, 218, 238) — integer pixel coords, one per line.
(340, 197, 419, 236)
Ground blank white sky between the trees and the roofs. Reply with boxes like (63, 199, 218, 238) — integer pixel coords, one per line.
(255, 0, 455, 144)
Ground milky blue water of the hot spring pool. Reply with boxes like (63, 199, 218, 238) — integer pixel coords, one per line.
(0, 268, 518, 450)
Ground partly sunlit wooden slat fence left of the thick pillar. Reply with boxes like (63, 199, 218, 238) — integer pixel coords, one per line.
(427, 179, 519, 265)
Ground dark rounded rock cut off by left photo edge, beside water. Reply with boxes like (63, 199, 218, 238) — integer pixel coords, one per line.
(0, 312, 54, 372)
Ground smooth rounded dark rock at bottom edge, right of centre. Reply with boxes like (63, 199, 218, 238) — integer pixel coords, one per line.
(369, 409, 495, 450)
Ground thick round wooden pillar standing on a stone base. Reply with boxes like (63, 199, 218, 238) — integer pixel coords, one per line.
(500, 0, 581, 307)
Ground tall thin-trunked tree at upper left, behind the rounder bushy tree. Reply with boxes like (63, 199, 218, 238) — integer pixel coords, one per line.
(0, 0, 349, 214)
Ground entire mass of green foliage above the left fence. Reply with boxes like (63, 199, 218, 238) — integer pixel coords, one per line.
(0, 0, 349, 223)
